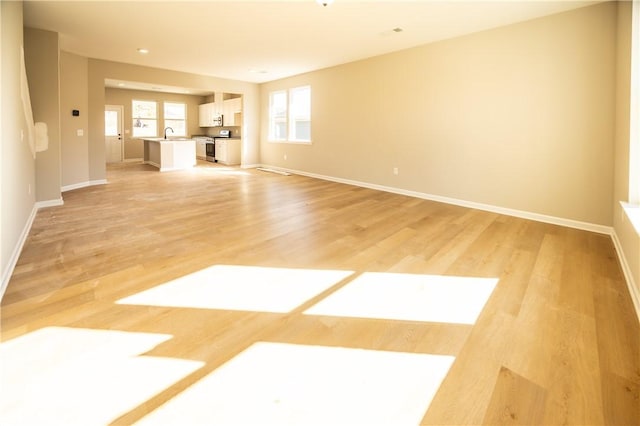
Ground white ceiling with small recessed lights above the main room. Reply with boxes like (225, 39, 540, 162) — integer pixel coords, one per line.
(24, 0, 598, 83)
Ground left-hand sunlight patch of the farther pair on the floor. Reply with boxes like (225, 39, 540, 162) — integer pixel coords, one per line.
(117, 265, 353, 313)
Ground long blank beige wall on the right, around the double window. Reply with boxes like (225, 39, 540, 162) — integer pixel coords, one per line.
(260, 3, 616, 226)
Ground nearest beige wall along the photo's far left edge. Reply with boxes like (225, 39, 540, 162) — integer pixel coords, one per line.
(0, 1, 36, 290)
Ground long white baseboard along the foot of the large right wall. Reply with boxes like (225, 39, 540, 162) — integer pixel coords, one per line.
(260, 164, 613, 235)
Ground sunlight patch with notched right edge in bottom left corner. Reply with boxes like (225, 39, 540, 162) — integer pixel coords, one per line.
(0, 327, 203, 426)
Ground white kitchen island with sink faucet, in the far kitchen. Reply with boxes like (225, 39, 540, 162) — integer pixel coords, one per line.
(143, 138, 196, 172)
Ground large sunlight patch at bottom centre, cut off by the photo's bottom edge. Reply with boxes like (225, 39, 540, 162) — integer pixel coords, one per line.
(138, 342, 454, 425)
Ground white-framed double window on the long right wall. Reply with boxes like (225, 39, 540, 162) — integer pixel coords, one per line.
(269, 86, 311, 142)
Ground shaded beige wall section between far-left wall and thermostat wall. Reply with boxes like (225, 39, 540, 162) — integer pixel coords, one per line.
(24, 28, 62, 202)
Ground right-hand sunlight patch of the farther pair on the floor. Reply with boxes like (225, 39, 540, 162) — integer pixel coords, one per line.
(304, 272, 498, 324)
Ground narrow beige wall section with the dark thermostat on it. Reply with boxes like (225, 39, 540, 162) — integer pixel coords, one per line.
(60, 52, 90, 187)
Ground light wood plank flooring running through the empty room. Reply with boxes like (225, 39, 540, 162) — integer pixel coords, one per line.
(0, 163, 640, 425)
